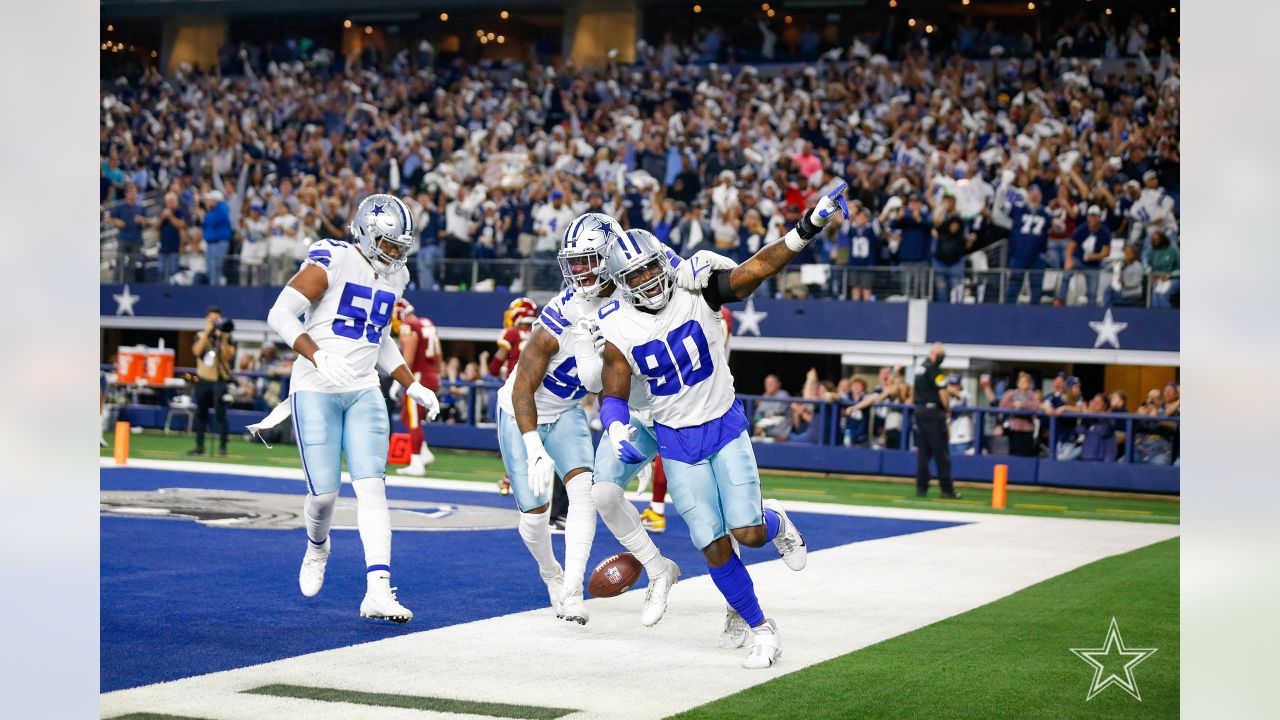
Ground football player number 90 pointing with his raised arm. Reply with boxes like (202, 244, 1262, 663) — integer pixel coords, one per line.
(596, 184, 849, 667)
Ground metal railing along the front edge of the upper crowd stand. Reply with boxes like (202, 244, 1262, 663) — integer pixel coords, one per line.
(101, 244, 1178, 307)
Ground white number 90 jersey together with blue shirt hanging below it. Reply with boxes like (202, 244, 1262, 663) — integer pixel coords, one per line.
(596, 277, 748, 462)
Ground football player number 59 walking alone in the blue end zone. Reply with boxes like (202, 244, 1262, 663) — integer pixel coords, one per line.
(268, 195, 439, 623)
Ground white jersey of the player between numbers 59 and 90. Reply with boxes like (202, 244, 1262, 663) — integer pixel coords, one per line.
(498, 283, 591, 425)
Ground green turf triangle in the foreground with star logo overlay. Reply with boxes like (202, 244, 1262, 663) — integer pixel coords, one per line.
(676, 539, 1179, 720)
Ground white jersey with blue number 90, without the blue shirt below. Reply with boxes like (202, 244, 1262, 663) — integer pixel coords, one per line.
(596, 283, 735, 429)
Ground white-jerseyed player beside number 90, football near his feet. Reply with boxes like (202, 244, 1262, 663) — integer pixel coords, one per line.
(498, 213, 732, 626)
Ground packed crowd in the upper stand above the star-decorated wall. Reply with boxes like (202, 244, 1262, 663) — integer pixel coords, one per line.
(100, 4, 1180, 306)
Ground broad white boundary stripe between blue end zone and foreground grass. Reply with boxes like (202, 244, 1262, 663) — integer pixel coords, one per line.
(101, 471, 1179, 720)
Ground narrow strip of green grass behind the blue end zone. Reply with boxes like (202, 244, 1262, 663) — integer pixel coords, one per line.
(101, 432, 1180, 523)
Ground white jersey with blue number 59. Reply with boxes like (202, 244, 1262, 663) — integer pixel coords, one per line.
(289, 240, 408, 392)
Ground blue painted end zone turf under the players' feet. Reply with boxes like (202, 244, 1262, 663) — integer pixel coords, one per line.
(100, 468, 963, 692)
